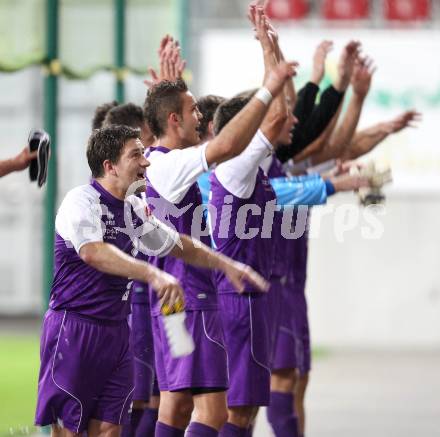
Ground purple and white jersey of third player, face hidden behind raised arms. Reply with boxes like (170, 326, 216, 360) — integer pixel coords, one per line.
(209, 130, 275, 293)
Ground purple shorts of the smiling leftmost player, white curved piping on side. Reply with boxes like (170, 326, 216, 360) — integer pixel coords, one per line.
(35, 310, 133, 433)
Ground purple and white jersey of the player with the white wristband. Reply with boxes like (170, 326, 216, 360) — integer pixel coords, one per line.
(147, 143, 217, 315)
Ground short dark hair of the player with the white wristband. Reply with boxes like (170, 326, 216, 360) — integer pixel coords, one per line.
(144, 79, 188, 138)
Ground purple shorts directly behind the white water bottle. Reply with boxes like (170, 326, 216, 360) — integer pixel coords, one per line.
(152, 310, 229, 391)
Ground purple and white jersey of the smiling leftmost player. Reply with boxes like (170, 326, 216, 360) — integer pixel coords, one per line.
(49, 181, 179, 320)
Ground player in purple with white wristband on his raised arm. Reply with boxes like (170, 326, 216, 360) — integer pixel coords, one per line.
(141, 30, 294, 436)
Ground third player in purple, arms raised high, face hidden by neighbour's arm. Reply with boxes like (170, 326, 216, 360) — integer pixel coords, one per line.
(206, 8, 295, 436)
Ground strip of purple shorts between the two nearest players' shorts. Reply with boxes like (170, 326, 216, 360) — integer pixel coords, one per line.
(131, 302, 158, 402)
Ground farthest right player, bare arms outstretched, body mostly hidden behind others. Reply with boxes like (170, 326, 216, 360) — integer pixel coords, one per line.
(282, 52, 420, 436)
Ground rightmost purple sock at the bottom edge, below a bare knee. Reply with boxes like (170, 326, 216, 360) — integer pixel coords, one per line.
(267, 391, 298, 437)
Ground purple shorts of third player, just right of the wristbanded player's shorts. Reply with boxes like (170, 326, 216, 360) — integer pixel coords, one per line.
(219, 292, 271, 407)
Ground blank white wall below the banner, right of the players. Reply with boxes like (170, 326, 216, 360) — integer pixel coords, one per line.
(306, 192, 440, 348)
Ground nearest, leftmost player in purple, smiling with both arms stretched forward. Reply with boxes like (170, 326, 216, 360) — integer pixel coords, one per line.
(35, 126, 264, 437)
